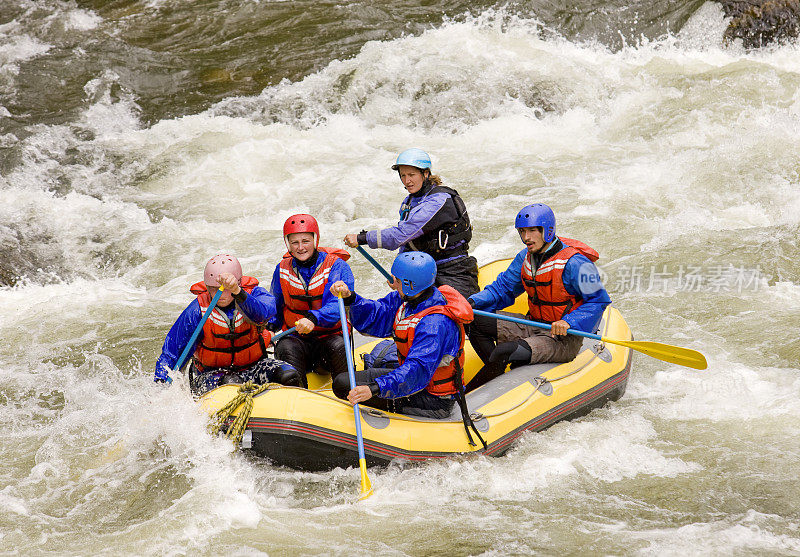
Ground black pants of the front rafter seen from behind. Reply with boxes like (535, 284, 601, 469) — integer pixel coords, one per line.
(333, 367, 455, 420)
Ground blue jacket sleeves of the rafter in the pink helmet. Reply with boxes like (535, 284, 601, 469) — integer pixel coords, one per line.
(156, 286, 277, 370)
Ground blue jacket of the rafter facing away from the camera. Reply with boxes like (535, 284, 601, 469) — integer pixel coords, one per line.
(350, 288, 461, 398)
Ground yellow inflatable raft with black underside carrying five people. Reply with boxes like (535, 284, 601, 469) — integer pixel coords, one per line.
(201, 260, 632, 471)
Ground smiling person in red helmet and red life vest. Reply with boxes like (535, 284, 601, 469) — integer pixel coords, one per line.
(272, 214, 355, 386)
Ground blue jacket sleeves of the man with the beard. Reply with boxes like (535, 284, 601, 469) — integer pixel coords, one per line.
(470, 242, 611, 333)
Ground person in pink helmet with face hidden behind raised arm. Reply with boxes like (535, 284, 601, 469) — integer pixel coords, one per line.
(155, 254, 300, 394)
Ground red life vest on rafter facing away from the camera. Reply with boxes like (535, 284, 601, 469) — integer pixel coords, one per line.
(393, 285, 474, 396)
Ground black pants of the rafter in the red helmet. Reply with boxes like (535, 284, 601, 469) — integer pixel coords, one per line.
(275, 333, 347, 388)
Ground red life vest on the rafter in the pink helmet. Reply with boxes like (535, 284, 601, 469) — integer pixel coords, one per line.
(190, 276, 272, 371)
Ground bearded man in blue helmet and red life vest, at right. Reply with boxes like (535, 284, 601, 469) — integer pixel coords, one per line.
(467, 203, 611, 390)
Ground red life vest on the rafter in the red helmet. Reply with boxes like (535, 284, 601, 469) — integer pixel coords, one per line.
(279, 248, 350, 337)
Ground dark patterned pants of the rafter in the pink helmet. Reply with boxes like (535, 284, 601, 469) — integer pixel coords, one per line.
(189, 356, 301, 395)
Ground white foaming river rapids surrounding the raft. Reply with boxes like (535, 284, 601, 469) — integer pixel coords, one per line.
(0, 6, 800, 554)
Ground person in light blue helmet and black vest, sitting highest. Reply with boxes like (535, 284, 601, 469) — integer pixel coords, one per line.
(344, 148, 478, 296)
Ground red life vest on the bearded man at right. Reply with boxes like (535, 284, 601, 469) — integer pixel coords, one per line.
(521, 238, 600, 323)
